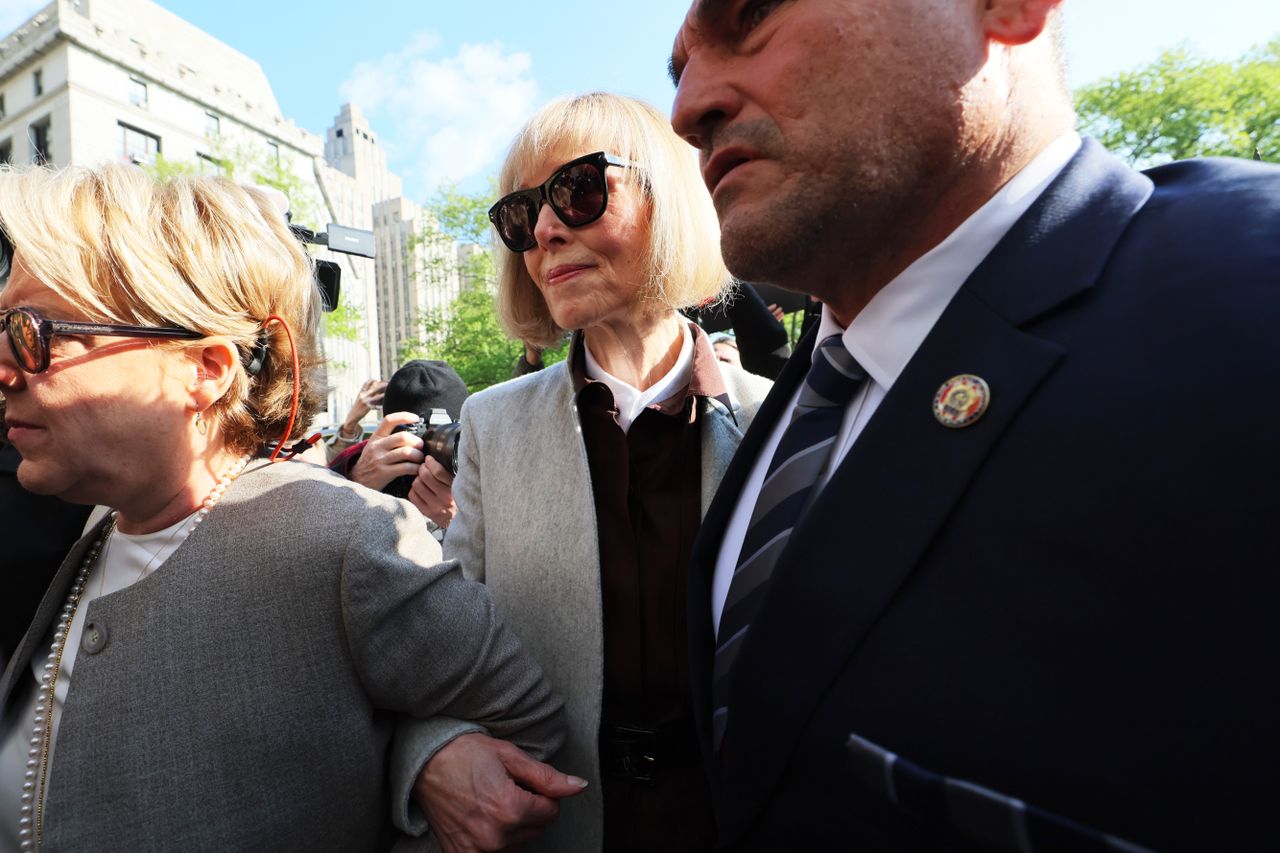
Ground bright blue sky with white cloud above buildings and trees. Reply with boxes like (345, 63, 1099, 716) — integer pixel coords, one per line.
(0, 0, 1280, 201)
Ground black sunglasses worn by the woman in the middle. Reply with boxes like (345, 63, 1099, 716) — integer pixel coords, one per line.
(489, 151, 635, 252)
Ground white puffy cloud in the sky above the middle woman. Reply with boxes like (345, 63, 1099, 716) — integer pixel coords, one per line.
(340, 32, 538, 200)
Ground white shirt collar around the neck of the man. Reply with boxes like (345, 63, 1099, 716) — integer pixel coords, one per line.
(818, 131, 1080, 391)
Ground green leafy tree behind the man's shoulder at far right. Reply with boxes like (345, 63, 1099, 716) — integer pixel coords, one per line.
(1075, 37, 1280, 165)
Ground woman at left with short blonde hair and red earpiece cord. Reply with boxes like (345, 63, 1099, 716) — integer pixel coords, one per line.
(0, 165, 570, 850)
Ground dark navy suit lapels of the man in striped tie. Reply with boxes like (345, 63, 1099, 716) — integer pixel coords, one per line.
(716, 142, 1151, 843)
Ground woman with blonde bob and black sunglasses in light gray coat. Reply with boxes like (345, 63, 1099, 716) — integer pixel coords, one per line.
(407, 93, 768, 852)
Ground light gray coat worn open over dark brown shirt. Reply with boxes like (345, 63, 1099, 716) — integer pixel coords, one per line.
(391, 362, 772, 850)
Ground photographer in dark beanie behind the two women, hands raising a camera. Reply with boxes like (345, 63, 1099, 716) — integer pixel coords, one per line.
(329, 360, 467, 530)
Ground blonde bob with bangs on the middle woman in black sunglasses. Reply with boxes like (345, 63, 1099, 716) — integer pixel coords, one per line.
(493, 92, 731, 347)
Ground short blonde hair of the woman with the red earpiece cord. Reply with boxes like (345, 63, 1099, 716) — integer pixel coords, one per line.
(0, 164, 324, 453)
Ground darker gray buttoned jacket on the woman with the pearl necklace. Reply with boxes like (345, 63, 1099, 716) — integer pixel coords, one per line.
(0, 462, 562, 850)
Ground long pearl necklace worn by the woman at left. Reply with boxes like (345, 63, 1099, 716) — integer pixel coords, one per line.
(18, 456, 250, 850)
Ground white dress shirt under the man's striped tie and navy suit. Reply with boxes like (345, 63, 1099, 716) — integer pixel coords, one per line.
(712, 131, 1080, 631)
